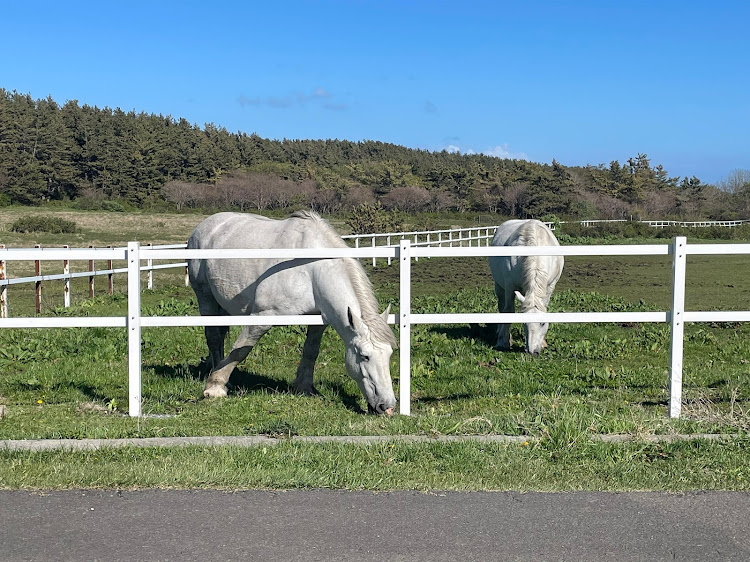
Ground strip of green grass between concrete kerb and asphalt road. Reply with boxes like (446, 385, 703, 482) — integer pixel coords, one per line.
(0, 439, 750, 491)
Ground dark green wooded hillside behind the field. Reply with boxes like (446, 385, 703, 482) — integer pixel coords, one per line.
(0, 89, 750, 219)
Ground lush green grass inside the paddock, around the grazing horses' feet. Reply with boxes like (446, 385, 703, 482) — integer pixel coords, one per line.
(0, 289, 750, 439)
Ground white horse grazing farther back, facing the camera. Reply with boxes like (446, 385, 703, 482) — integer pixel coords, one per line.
(490, 220, 563, 355)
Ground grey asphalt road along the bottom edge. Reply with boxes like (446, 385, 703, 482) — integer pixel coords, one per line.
(0, 490, 750, 562)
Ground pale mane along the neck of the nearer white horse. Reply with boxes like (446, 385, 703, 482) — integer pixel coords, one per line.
(289, 211, 397, 349)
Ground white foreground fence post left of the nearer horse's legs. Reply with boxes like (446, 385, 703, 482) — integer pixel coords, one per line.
(127, 242, 141, 417)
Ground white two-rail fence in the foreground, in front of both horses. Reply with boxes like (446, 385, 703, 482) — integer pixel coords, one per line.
(0, 237, 750, 417)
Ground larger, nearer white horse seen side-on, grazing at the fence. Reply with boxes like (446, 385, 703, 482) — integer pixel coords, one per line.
(187, 211, 396, 414)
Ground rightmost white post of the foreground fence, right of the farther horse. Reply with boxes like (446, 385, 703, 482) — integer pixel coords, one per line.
(669, 236, 687, 418)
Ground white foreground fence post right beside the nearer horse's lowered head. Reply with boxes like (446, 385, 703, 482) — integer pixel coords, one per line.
(398, 238, 411, 416)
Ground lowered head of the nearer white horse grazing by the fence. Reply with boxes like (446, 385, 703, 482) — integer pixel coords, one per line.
(345, 307, 396, 414)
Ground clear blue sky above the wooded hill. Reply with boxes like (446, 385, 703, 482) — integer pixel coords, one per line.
(0, 0, 750, 182)
